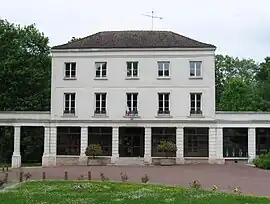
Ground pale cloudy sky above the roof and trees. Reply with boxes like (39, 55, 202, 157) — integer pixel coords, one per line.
(0, 0, 270, 61)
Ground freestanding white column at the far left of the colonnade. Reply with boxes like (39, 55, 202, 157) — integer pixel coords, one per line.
(11, 126, 21, 168)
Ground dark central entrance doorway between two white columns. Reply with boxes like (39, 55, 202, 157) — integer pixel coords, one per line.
(119, 127, 144, 157)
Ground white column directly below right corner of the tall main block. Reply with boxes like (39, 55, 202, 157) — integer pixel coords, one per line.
(208, 128, 217, 164)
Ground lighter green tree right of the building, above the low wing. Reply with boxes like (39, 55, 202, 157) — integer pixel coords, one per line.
(216, 55, 260, 111)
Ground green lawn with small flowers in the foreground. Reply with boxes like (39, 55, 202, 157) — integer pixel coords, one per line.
(0, 181, 270, 204)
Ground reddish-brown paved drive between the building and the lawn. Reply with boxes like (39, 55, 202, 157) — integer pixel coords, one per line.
(0, 164, 270, 196)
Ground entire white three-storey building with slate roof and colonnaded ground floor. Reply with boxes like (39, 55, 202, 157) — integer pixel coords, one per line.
(0, 31, 270, 168)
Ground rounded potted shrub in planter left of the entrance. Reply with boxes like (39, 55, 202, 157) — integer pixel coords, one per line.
(85, 144, 102, 166)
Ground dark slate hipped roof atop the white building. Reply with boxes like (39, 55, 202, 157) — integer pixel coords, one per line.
(52, 31, 215, 49)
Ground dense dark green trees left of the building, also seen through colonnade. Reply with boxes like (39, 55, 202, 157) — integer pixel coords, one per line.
(0, 19, 51, 162)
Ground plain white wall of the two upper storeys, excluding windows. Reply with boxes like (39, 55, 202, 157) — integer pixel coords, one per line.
(51, 49, 215, 121)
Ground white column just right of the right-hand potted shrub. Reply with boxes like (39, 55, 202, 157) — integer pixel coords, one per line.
(176, 127, 185, 164)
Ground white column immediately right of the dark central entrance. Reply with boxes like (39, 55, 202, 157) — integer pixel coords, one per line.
(144, 127, 152, 165)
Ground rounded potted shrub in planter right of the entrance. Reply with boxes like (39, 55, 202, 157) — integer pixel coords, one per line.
(157, 141, 177, 165)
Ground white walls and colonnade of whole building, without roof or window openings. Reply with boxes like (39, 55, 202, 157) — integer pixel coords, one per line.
(0, 45, 270, 168)
